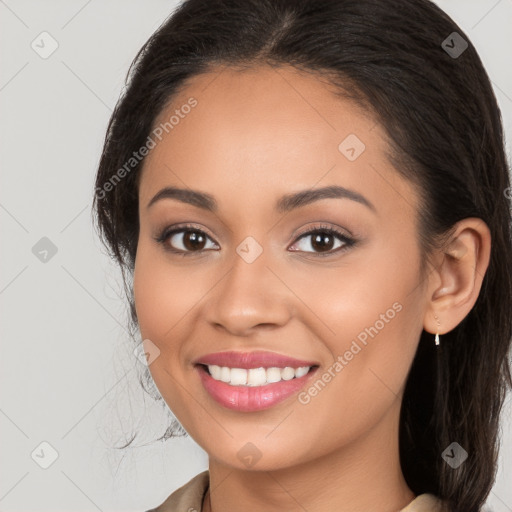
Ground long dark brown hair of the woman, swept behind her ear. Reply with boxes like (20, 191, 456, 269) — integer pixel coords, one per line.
(94, 0, 512, 512)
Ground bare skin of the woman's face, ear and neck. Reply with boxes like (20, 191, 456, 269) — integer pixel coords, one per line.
(134, 67, 490, 512)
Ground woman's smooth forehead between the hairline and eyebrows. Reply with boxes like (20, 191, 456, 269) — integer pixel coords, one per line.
(140, 63, 412, 218)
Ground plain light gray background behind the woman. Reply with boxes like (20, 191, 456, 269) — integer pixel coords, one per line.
(0, 0, 512, 512)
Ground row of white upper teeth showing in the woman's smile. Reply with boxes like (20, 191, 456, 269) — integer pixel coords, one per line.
(208, 364, 311, 387)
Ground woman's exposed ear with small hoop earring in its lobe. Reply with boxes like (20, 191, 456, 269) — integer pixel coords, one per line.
(423, 217, 491, 334)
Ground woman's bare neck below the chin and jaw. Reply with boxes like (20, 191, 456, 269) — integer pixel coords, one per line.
(203, 401, 415, 512)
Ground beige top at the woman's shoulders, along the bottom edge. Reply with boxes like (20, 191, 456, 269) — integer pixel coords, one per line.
(146, 470, 441, 512)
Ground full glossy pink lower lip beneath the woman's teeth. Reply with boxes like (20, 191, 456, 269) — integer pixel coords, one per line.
(197, 365, 317, 412)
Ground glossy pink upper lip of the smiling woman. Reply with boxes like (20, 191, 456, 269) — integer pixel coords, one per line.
(194, 350, 318, 370)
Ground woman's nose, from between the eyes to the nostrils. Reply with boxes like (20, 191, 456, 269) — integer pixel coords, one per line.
(206, 244, 292, 337)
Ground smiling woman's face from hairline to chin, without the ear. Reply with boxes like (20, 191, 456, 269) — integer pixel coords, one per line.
(134, 67, 427, 470)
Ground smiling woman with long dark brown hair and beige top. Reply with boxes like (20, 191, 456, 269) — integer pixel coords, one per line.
(95, 0, 512, 512)
